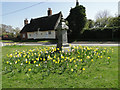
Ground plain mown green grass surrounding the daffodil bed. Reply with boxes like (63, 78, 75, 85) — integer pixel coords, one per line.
(2, 46, 118, 88)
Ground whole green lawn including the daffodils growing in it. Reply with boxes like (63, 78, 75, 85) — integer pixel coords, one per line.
(2, 46, 118, 88)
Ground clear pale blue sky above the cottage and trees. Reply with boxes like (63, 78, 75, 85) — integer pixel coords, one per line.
(0, 0, 118, 29)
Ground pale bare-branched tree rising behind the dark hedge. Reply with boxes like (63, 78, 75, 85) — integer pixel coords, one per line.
(95, 10, 110, 27)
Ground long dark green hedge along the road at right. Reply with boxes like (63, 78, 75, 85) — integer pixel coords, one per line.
(69, 27, 120, 40)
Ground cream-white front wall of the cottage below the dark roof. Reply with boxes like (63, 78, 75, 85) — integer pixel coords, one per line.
(27, 30, 55, 39)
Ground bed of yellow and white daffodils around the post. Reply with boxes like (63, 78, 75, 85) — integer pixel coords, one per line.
(3, 46, 113, 76)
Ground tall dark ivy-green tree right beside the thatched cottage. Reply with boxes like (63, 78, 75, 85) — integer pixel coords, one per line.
(66, 5, 86, 36)
